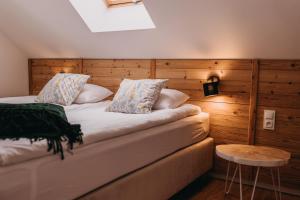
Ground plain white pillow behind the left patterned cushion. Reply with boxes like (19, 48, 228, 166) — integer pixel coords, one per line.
(74, 84, 113, 104)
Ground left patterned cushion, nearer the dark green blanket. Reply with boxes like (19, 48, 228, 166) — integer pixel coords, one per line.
(36, 73, 90, 106)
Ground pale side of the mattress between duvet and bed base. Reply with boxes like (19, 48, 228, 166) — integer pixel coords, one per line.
(0, 96, 209, 200)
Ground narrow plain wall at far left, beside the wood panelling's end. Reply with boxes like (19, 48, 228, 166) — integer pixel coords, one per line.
(0, 32, 29, 97)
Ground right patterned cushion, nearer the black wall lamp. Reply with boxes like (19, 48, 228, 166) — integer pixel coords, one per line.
(106, 79, 167, 114)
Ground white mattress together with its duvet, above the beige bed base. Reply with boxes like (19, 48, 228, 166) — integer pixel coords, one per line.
(0, 97, 209, 199)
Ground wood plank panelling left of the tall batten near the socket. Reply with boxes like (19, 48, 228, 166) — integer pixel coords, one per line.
(29, 59, 253, 153)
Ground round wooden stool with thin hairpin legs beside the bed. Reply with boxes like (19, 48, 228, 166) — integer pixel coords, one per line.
(216, 144, 291, 200)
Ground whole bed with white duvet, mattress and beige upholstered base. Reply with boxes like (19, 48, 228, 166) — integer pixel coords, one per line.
(0, 96, 213, 199)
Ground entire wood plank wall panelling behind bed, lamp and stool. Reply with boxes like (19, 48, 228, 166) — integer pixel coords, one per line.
(29, 59, 300, 190)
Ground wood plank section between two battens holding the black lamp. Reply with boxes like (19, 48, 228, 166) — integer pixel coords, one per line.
(156, 60, 253, 177)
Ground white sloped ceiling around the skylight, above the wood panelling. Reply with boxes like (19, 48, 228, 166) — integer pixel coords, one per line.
(0, 0, 300, 58)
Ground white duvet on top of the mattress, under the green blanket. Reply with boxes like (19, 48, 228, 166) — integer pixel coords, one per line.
(0, 96, 201, 165)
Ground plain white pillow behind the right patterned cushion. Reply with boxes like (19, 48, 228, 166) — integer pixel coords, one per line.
(153, 89, 190, 110)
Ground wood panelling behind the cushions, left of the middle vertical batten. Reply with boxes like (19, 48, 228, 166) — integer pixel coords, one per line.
(29, 59, 154, 95)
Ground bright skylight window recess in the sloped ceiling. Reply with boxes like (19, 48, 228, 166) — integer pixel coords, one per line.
(69, 0, 155, 32)
